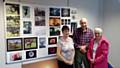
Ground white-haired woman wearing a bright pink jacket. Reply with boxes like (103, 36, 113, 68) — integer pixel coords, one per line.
(87, 28, 109, 68)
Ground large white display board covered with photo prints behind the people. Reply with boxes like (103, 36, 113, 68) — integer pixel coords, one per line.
(4, 3, 77, 63)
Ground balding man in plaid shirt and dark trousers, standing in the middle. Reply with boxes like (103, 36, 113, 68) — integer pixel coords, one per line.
(73, 18, 93, 68)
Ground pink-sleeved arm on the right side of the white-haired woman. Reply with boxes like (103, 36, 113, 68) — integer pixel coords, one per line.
(95, 42, 109, 63)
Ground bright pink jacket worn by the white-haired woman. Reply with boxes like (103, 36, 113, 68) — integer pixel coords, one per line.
(87, 37, 109, 68)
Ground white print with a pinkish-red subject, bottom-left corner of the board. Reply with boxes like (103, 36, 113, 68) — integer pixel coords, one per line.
(10, 52, 22, 61)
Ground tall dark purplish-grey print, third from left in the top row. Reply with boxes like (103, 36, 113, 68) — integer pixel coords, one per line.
(34, 7, 46, 26)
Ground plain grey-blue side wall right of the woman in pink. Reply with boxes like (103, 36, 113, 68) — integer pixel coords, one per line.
(103, 0, 120, 68)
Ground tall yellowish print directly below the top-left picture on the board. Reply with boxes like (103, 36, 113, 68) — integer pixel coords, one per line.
(6, 16, 20, 37)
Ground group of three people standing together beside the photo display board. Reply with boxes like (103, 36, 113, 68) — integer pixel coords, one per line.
(57, 18, 109, 68)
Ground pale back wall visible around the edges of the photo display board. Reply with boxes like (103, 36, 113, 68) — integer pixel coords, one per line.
(0, 0, 102, 68)
